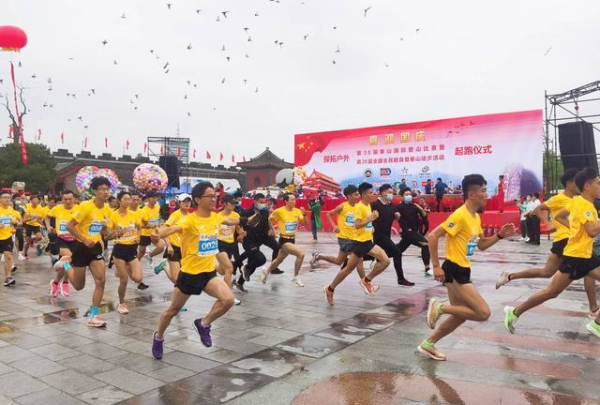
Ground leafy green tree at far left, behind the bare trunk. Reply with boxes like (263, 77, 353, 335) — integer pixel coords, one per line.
(0, 143, 57, 192)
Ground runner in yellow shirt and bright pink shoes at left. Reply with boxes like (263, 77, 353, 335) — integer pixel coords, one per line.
(45, 190, 75, 298)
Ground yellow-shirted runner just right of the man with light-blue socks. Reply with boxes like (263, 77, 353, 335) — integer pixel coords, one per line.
(109, 191, 142, 315)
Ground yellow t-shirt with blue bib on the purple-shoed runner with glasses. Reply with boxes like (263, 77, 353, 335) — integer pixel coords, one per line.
(177, 212, 222, 274)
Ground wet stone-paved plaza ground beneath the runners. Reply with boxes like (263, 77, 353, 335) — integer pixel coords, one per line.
(0, 234, 600, 405)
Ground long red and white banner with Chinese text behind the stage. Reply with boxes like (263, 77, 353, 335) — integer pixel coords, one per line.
(294, 110, 543, 201)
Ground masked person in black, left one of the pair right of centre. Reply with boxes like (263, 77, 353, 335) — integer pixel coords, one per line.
(371, 184, 415, 287)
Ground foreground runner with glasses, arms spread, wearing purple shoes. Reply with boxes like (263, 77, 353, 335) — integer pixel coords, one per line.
(152, 182, 253, 360)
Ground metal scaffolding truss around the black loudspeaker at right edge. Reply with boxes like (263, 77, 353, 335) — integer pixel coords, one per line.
(544, 81, 600, 194)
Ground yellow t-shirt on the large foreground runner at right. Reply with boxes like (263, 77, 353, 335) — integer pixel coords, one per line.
(442, 205, 483, 267)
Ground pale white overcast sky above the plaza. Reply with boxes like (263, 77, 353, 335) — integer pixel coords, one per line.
(0, 0, 600, 163)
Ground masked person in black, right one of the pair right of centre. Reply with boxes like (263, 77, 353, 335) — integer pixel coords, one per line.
(394, 190, 432, 277)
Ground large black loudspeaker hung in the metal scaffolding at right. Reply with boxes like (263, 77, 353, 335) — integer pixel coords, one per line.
(558, 121, 598, 171)
